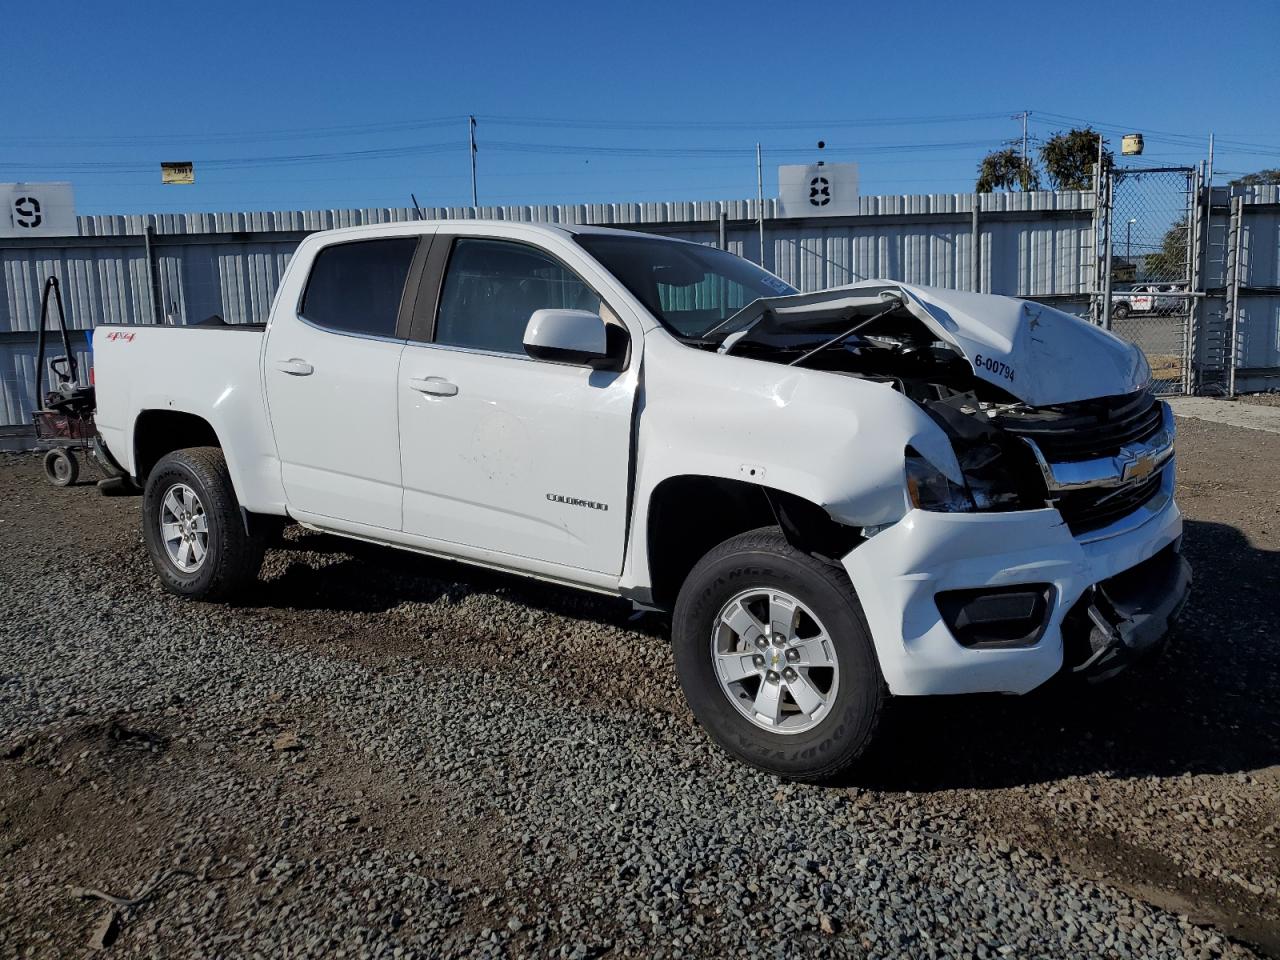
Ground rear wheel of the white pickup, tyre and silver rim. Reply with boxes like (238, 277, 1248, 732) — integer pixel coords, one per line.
(142, 447, 262, 600)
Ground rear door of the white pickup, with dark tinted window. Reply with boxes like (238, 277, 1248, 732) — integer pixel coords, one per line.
(264, 236, 430, 531)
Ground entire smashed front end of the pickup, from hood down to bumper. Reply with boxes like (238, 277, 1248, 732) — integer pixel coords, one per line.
(701, 284, 1190, 694)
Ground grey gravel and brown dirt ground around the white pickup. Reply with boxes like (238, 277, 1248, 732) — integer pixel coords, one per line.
(0, 421, 1280, 957)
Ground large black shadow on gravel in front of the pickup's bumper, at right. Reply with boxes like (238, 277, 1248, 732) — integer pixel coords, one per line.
(856, 521, 1280, 791)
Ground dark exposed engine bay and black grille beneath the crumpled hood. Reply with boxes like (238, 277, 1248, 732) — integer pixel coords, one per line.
(717, 292, 1162, 531)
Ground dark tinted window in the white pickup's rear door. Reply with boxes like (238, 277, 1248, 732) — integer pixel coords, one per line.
(302, 237, 417, 337)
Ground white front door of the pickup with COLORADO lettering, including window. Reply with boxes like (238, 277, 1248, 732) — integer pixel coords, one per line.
(399, 234, 639, 575)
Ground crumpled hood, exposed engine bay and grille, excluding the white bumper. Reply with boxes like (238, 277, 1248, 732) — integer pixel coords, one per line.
(716, 283, 1172, 538)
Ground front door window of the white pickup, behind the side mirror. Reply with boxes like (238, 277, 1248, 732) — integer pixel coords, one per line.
(435, 238, 600, 355)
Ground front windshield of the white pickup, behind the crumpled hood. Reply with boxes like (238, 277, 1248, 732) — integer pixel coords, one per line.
(575, 233, 797, 339)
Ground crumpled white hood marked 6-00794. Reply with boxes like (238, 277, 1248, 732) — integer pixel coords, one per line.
(753, 280, 1151, 407)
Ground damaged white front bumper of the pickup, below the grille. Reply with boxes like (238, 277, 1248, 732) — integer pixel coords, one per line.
(844, 461, 1189, 695)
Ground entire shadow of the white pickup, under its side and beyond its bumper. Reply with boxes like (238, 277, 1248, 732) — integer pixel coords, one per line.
(247, 521, 1280, 791)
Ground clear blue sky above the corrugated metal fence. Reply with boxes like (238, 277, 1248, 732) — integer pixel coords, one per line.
(0, 0, 1280, 214)
